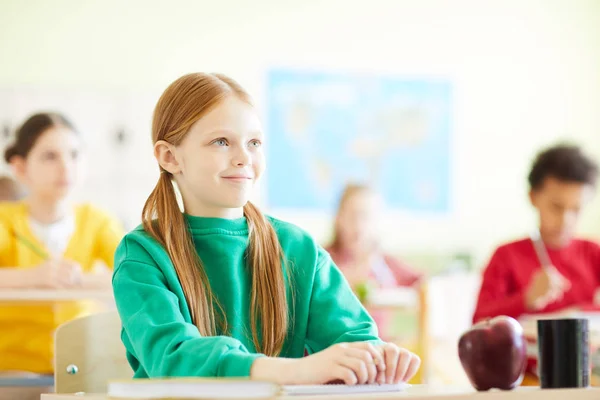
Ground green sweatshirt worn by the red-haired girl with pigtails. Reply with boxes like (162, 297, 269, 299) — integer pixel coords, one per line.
(113, 215, 378, 378)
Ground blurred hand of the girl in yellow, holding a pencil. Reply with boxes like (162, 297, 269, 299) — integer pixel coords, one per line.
(31, 259, 82, 289)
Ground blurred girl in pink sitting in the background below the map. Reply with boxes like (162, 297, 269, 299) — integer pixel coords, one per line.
(327, 184, 422, 336)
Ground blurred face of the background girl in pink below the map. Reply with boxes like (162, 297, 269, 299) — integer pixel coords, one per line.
(337, 190, 380, 249)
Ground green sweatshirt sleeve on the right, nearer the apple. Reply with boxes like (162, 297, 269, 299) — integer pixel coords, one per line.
(306, 248, 381, 353)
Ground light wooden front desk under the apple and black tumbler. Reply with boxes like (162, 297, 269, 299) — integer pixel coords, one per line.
(41, 385, 600, 400)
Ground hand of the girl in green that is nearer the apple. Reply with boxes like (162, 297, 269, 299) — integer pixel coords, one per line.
(377, 343, 421, 384)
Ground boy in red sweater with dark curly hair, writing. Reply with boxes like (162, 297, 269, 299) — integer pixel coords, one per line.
(473, 145, 600, 322)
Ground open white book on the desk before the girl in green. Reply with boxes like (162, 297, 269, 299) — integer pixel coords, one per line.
(107, 378, 409, 400)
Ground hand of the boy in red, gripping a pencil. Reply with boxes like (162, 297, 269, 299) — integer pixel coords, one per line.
(525, 266, 571, 311)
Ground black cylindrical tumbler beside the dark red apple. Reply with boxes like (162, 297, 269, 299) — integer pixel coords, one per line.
(537, 318, 591, 389)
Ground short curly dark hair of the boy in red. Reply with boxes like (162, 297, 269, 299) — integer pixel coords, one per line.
(528, 144, 598, 190)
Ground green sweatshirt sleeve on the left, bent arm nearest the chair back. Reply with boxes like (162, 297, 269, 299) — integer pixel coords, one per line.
(113, 261, 261, 378)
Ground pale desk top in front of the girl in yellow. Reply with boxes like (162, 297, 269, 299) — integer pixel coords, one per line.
(0, 289, 113, 302)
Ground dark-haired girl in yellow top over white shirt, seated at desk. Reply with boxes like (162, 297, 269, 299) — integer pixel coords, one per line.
(0, 113, 122, 374)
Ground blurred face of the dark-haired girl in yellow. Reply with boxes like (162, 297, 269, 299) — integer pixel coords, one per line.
(14, 126, 81, 201)
